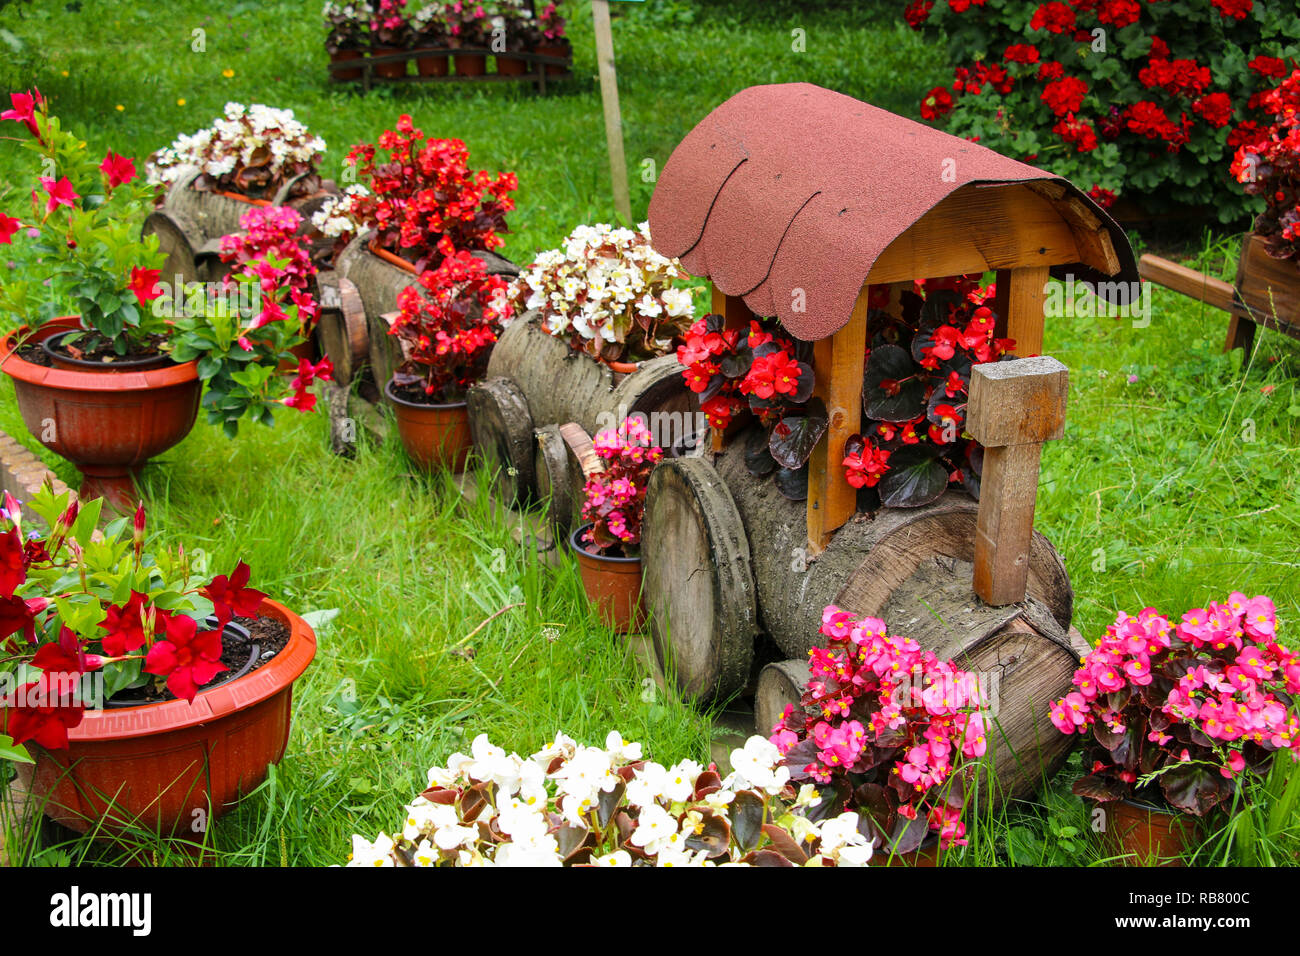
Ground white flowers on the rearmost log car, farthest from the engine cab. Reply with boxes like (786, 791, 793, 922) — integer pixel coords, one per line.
(147, 103, 325, 185)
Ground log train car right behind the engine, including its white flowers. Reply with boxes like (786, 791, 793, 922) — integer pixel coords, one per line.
(469, 224, 698, 522)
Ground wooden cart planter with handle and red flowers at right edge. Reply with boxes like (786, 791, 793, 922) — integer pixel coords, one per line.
(1140, 70, 1300, 355)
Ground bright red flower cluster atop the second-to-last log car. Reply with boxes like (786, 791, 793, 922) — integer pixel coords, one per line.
(347, 114, 519, 272)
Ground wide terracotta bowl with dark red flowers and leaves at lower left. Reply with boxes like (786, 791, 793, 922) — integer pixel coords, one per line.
(0, 494, 316, 835)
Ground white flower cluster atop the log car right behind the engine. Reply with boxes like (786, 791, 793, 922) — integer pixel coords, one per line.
(511, 222, 694, 351)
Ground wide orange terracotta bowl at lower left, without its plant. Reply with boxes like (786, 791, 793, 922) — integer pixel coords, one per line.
(18, 598, 316, 838)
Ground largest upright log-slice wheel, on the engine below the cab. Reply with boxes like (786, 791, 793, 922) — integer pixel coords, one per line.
(641, 458, 758, 704)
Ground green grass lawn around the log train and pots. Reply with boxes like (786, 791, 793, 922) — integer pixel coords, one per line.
(0, 0, 1300, 865)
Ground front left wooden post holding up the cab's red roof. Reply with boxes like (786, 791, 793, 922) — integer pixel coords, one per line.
(807, 285, 867, 557)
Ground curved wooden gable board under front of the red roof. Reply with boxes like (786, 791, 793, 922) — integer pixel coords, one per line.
(867, 185, 1097, 285)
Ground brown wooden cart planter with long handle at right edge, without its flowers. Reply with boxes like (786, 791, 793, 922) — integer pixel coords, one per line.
(1138, 233, 1300, 355)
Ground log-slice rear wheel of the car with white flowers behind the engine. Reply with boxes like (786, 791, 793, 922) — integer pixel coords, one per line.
(467, 378, 537, 506)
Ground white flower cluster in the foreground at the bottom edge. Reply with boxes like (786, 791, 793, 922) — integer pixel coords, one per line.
(347, 731, 871, 866)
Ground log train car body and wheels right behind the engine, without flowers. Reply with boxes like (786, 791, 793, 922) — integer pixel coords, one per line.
(469, 312, 699, 535)
